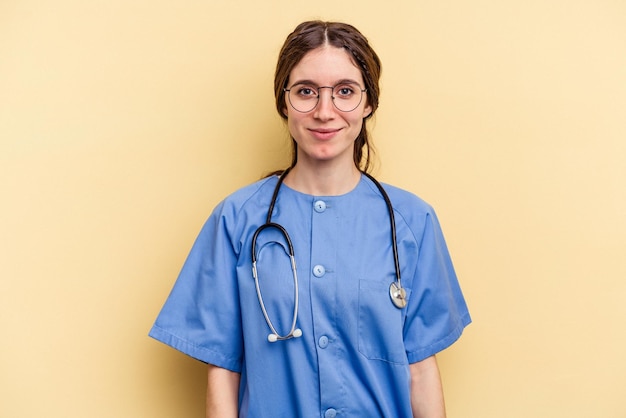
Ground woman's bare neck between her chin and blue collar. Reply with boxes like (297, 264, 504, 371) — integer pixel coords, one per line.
(285, 162, 361, 196)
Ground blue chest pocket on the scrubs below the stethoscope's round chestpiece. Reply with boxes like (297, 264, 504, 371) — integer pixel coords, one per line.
(358, 280, 411, 364)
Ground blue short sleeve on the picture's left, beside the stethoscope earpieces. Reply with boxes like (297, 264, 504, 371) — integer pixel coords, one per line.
(149, 203, 243, 372)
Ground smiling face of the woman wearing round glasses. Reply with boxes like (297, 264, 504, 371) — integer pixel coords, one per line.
(283, 46, 372, 165)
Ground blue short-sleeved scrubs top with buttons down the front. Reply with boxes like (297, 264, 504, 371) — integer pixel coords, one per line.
(150, 176, 471, 418)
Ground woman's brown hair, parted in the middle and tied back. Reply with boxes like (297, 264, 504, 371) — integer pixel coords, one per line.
(274, 20, 382, 172)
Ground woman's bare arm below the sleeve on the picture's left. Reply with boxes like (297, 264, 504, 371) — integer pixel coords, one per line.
(206, 364, 241, 418)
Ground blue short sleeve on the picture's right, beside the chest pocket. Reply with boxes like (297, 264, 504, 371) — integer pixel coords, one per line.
(404, 208, 471, 363)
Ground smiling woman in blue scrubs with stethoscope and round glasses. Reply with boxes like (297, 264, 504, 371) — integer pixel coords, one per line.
(150, 21, 470, 418)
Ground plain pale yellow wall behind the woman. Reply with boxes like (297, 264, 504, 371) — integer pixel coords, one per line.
(0, 0, 626, 418)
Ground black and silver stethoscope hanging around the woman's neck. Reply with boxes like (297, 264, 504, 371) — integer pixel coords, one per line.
(252, 168, 407, 343)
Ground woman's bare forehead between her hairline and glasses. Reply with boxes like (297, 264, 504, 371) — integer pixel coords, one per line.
(289, 45, 363, 85)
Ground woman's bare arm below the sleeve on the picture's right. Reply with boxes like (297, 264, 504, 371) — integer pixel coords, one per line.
(409, 356, 446, 418)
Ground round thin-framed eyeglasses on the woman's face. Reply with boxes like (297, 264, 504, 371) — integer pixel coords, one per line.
(284, 82, 367, 113)
